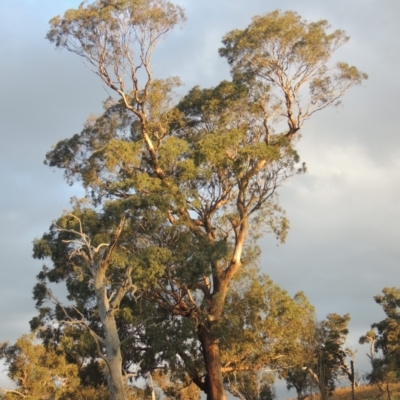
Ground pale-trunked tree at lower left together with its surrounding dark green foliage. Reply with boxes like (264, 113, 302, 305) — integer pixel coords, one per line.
(31, 204, 159, 399)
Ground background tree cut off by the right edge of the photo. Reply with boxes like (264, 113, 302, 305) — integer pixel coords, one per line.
(360, 287, 400, 398)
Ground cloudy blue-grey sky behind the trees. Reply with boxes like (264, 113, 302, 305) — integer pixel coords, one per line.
(0, 0, 400, 396)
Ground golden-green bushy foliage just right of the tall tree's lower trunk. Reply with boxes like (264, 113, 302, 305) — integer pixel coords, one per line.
(220, 268, 315, 372)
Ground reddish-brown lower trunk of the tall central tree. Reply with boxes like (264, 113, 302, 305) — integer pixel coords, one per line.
(198, 324, 226, 400)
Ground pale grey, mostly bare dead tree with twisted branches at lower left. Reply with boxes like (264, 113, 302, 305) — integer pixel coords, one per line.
(32, 208, 136, 400)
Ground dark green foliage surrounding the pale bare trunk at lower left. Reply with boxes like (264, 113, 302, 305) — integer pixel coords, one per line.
(31, 203, 178, 376)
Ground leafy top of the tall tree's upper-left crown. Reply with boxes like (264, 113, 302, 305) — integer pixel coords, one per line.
(47, 0, 184, 71)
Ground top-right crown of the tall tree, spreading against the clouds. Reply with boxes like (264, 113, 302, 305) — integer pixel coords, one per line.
(220, 11, 367, 134)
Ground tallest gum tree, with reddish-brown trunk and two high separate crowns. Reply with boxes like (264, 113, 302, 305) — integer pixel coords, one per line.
(43, 0, 367, 400)
